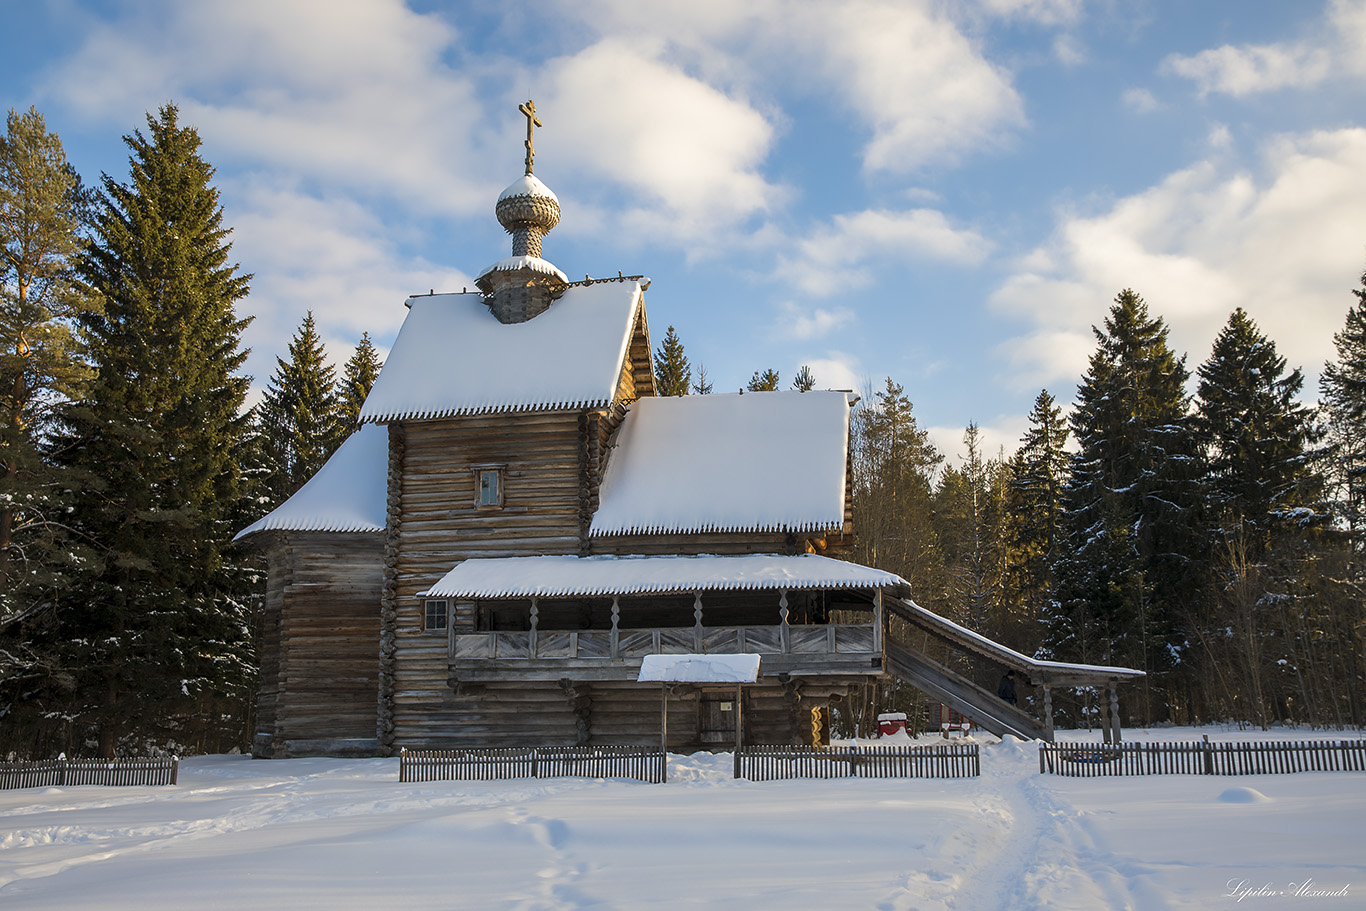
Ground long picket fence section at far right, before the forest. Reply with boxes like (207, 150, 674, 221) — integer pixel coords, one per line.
(1038, 738, 1366, 779)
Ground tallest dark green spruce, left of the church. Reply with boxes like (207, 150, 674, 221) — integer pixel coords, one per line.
(63, 105, 253, 755)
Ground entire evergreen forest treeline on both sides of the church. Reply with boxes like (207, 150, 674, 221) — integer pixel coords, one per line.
(8, 105, 1366, 757)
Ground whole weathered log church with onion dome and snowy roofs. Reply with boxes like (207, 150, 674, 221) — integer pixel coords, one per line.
(239, 102, 1132, 758)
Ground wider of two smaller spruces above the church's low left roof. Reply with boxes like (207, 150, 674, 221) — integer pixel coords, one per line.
(258, 310, 340, 505)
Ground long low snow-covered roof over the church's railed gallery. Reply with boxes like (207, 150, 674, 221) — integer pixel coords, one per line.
(419, 553, 904, 600)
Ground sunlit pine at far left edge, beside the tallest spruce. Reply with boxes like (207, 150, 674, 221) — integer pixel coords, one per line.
(0, 108, 90, 710)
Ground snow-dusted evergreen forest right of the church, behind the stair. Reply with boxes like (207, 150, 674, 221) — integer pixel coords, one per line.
(656, 292, 1366, 732)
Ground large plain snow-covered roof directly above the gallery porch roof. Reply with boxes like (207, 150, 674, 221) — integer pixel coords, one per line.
(591, 392, 850, 535)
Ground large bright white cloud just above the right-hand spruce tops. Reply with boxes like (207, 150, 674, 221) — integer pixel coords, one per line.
(992, 128, 1366, 385)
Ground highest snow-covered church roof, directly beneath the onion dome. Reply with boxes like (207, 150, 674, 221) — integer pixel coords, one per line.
(361, 281, 641, 423)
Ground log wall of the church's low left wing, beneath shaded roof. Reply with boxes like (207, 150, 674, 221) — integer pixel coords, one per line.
(251, 531, 384, 758)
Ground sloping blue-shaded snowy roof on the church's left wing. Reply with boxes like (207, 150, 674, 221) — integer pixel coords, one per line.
(234, 425, 389, 541)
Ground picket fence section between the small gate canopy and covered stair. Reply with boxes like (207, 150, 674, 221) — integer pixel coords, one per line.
(735, 743, 982, 781)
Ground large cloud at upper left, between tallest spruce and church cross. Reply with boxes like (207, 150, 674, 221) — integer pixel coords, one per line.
(48, 0, 492, 212)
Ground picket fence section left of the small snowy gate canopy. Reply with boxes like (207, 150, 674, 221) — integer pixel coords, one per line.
(399, 747, 665, 783)
